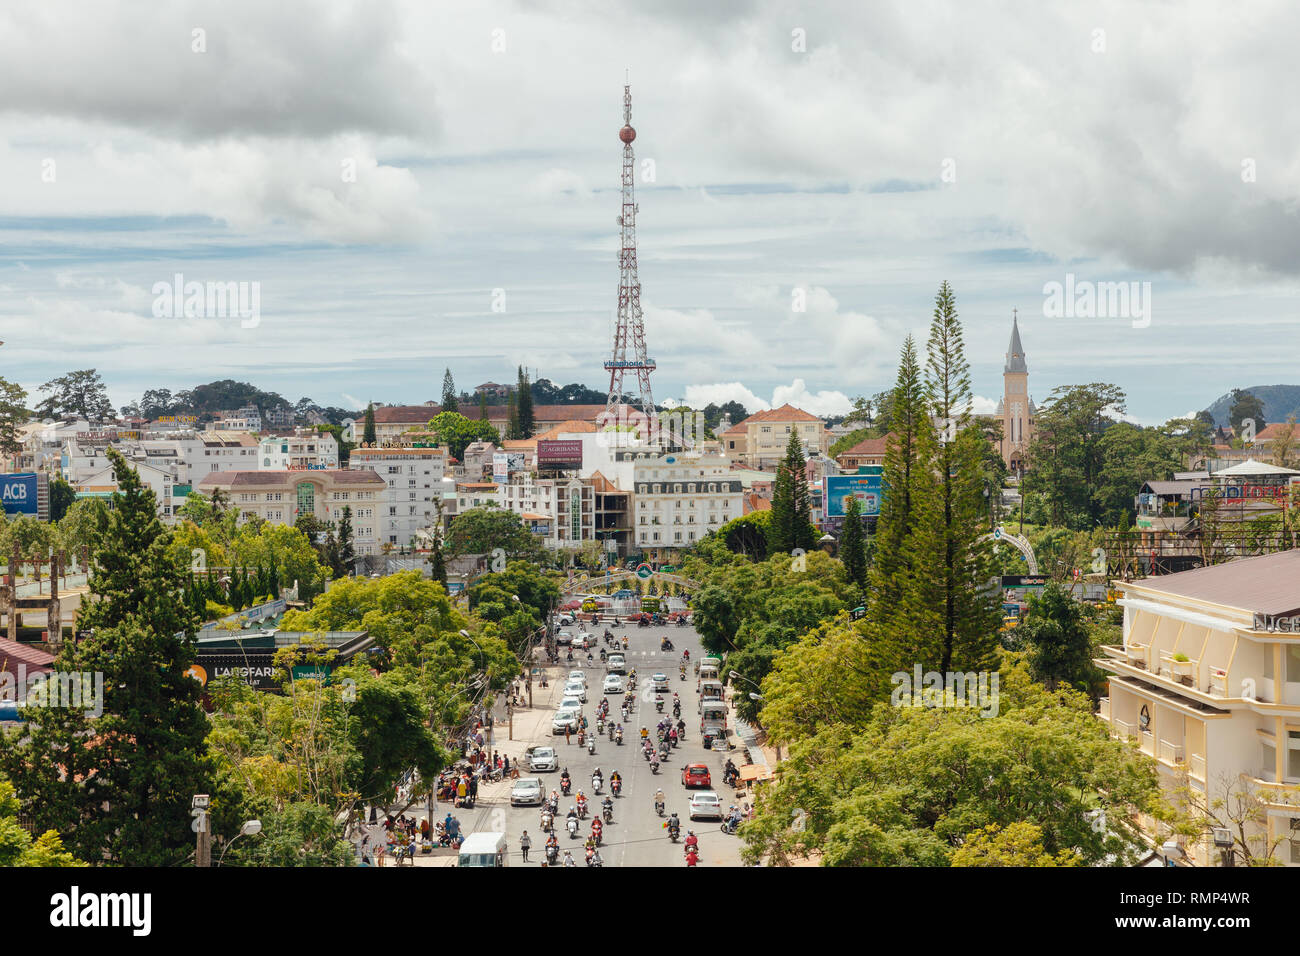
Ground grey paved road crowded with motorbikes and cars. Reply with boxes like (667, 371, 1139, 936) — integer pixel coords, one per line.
(491, 627, 742, 866)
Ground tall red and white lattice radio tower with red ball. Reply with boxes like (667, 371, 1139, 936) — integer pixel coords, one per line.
(605, 86, 657, 421)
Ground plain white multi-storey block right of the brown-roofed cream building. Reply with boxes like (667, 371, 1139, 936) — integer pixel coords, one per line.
(347, 446, 447, 548)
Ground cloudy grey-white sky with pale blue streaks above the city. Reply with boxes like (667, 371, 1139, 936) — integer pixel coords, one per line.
(0, 0, 1300, 423)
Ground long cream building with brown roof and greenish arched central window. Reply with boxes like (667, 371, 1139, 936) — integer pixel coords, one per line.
(195, 468, 386, 554)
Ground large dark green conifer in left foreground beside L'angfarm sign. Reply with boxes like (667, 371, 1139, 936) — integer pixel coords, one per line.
(0, 449, 216, 866)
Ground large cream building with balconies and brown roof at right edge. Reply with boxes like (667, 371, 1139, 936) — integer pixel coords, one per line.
(1097, 550, 1300, 866)
